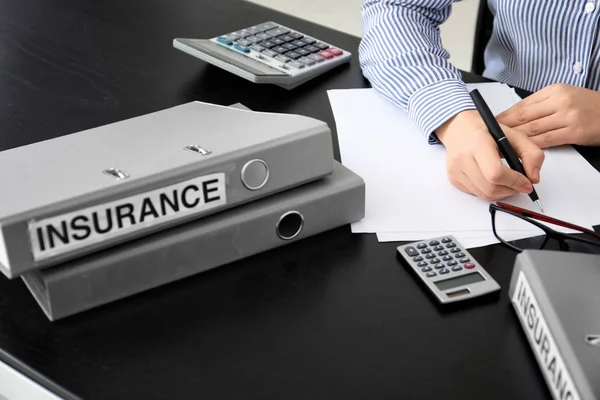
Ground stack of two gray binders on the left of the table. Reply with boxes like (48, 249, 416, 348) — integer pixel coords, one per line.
(0, 102, 365, 320)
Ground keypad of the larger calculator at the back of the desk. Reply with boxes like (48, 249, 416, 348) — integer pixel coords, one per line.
(216, 22, 344, 70)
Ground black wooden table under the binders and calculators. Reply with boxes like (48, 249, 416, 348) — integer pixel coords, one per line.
(0, 0, 600, 400)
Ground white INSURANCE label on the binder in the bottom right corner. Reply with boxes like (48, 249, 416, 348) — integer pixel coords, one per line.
(512, 271, 581, 400)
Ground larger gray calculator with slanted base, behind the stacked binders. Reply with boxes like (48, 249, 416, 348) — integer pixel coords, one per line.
(173, 22, 352, 89)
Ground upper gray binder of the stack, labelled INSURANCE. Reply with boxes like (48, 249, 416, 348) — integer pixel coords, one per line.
(0, 102, 333, 278)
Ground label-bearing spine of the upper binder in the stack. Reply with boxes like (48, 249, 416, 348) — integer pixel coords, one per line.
(0, 129, 333, 278)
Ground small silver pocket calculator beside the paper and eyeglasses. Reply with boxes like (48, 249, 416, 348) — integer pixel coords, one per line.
(396, 235, 500, 304)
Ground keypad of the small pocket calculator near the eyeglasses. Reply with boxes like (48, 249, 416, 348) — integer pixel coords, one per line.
(404, 237, 475, 278)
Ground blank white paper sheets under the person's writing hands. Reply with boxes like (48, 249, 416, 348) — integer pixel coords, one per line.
(328, 83, 600, 247)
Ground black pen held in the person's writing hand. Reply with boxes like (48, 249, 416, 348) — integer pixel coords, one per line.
(471, 89, 544, 212)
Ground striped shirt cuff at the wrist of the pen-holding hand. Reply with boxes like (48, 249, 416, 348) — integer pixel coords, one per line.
(408, 79, 475, 144)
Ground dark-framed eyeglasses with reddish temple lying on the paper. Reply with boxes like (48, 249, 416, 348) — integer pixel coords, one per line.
(489, 202, 600, 253)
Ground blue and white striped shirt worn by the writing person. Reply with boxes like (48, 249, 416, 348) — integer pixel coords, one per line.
(359, 0, 600, 143)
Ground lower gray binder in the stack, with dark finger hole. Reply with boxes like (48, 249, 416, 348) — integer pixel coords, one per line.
(22, 162, 365, 320)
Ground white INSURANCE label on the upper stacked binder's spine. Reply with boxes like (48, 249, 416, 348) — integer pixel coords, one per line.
(29, 173, 227, 260)
